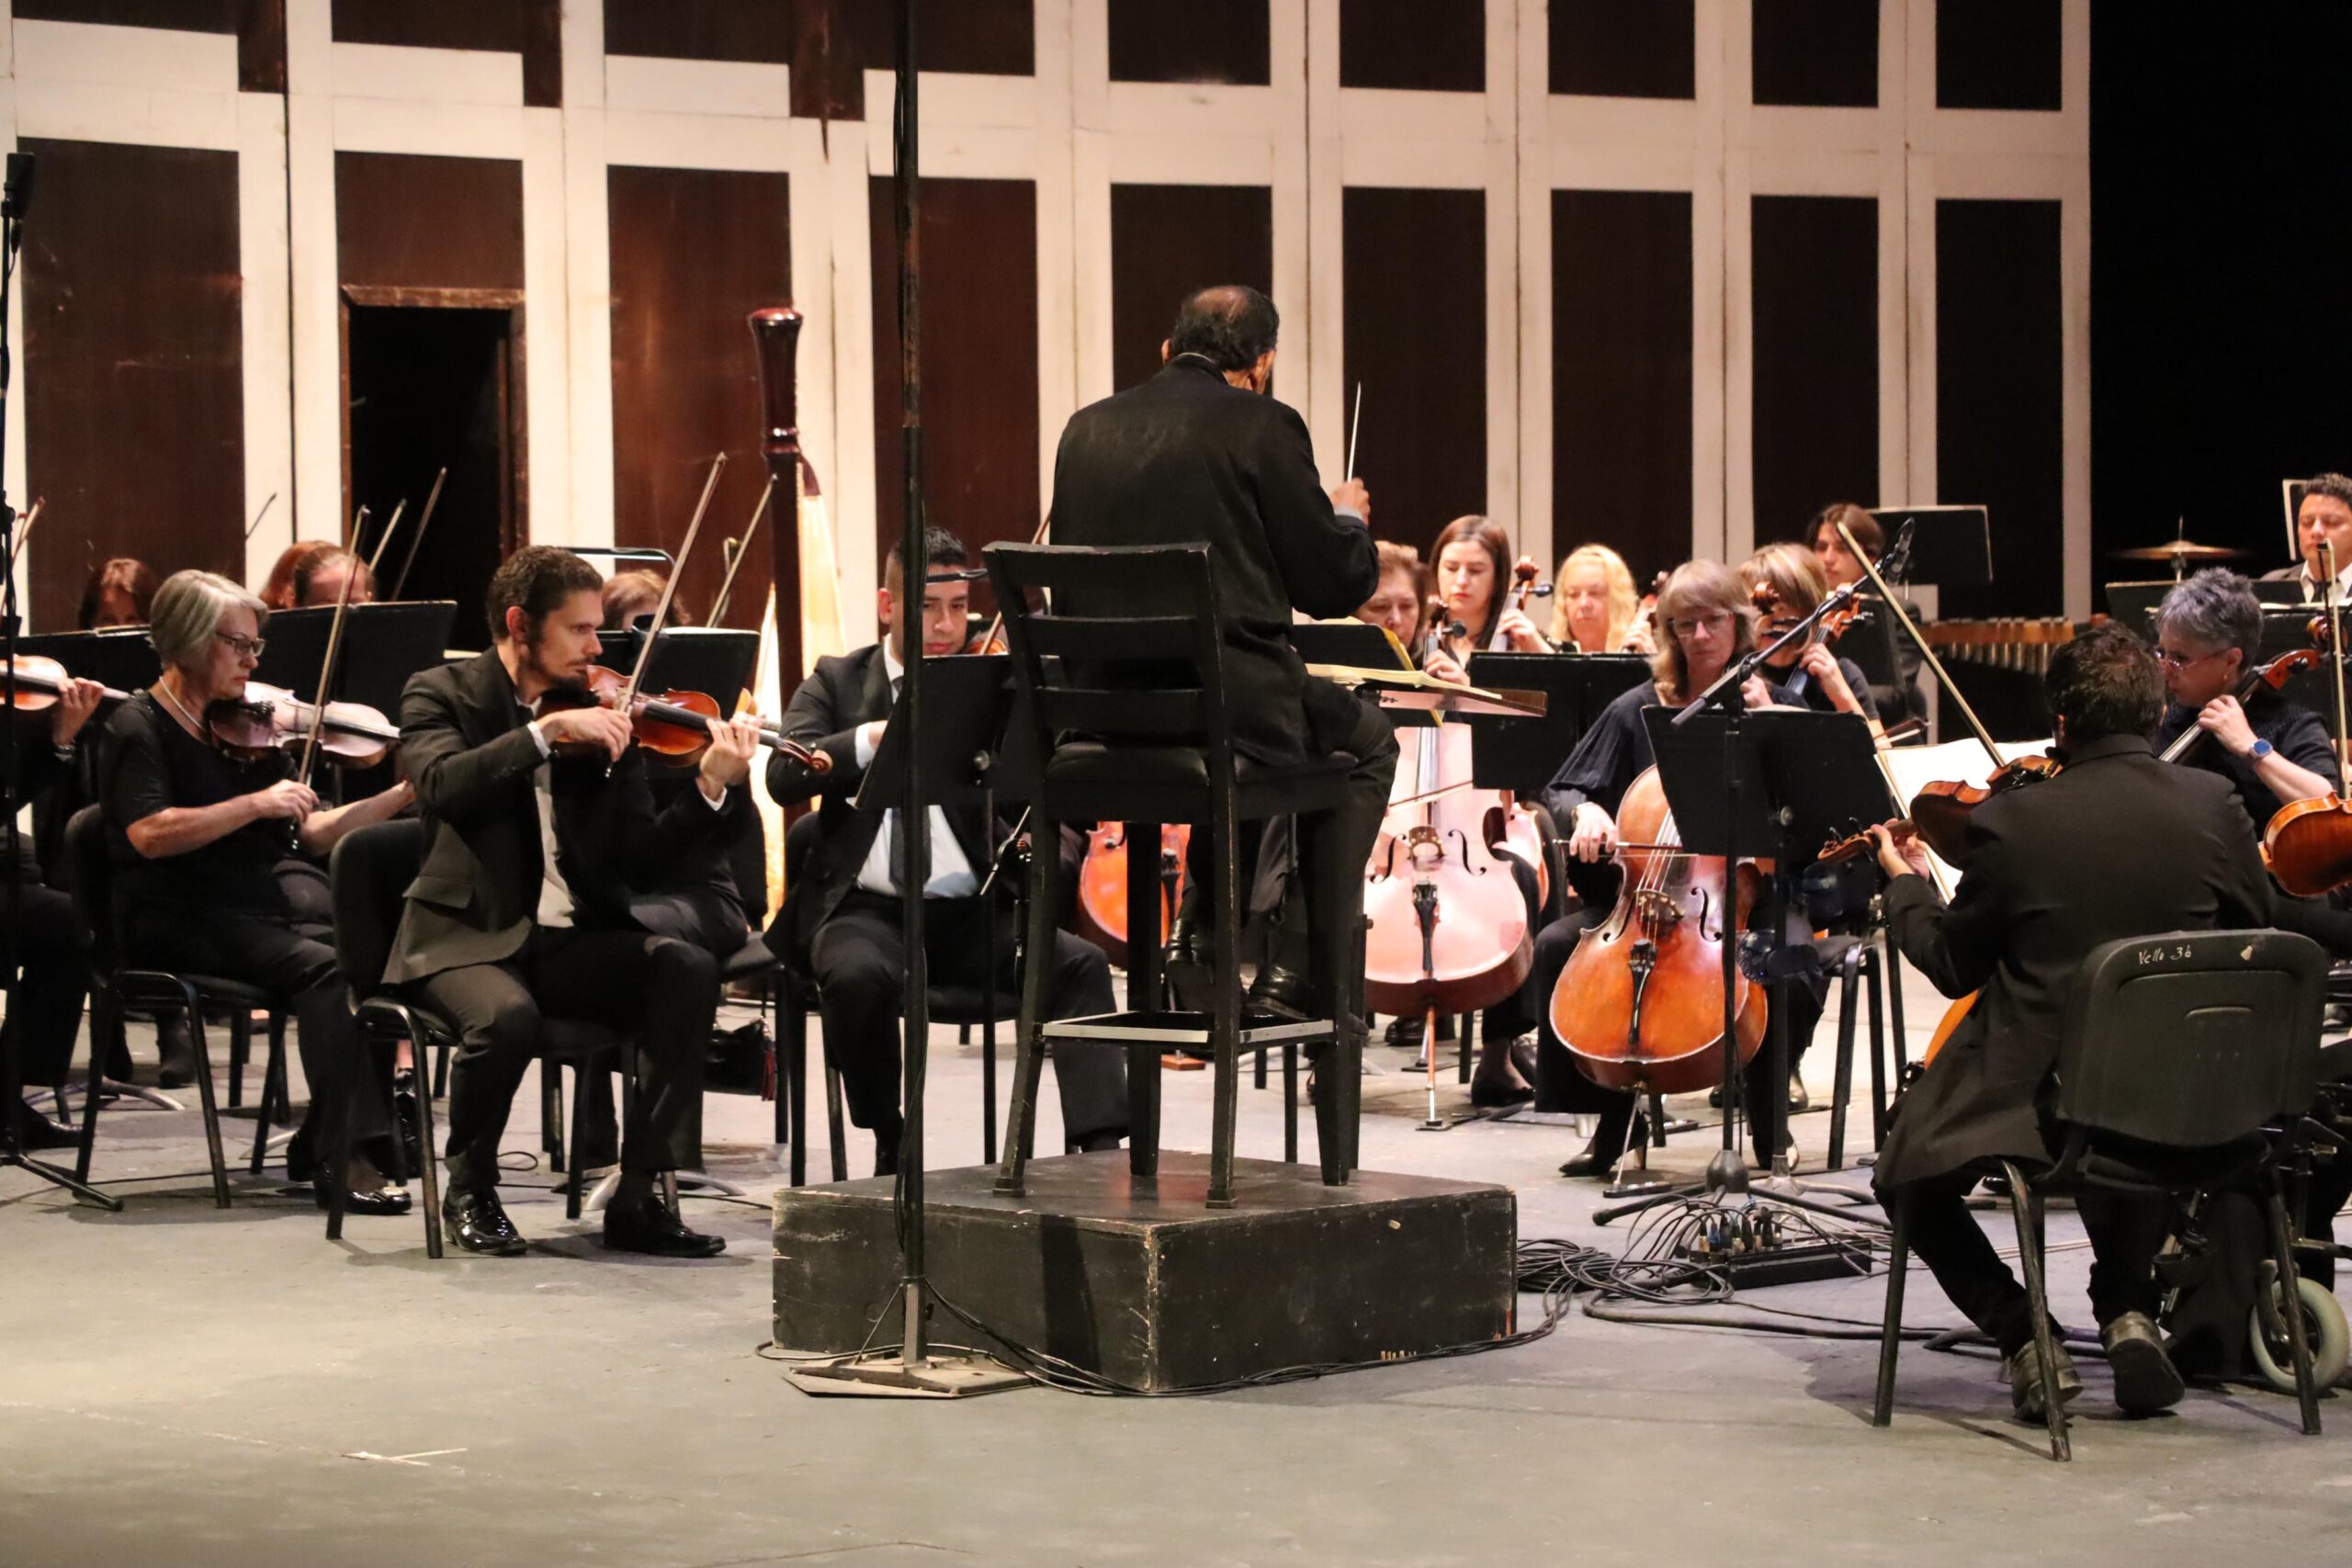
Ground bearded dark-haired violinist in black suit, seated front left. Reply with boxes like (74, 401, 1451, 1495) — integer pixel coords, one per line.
(383, 546, 760, 1258)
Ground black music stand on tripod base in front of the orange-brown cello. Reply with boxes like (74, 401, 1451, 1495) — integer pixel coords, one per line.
(1592, 705, 1895, 1224)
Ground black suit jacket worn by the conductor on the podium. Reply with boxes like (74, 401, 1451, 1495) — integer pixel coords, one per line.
(1054, 360, 1381, 761)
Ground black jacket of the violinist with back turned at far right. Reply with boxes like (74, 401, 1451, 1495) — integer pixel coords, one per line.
(1874, 736, 2272, 1185)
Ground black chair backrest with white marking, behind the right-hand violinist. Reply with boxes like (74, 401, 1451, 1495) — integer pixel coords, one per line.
(2058, 931, 2328, 1147)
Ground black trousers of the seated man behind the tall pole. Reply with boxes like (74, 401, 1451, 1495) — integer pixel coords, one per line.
(809, 888, 1126, 1143)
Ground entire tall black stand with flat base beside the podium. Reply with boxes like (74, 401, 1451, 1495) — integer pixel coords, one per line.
(786, 0, 1028, 1399)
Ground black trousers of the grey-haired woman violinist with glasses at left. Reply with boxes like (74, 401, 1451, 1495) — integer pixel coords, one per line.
(125, 884, 393, 1149)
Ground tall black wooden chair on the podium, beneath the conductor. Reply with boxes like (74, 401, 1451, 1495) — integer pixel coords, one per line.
(986, 546, 1362, 1208)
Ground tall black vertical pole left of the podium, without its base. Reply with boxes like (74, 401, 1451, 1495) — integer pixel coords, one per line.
(891, 0, 926, 1368)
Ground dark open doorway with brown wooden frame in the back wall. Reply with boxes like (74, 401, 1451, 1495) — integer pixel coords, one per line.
(344, 289, 525, 649)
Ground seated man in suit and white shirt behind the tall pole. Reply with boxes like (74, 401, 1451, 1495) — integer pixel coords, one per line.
(767, 529, 1126, 1176)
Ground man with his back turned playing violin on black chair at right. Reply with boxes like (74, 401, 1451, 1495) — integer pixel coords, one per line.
(1872, 626, 2269, 1420)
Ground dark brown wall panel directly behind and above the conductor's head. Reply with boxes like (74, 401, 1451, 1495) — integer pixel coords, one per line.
(1110, 186, 1275, 390)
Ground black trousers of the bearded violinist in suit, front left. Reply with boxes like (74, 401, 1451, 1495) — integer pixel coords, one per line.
(416, 926, 719, 1192)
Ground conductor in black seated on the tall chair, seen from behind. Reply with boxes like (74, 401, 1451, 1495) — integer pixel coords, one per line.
(1054, 287, 1397, 1053)
